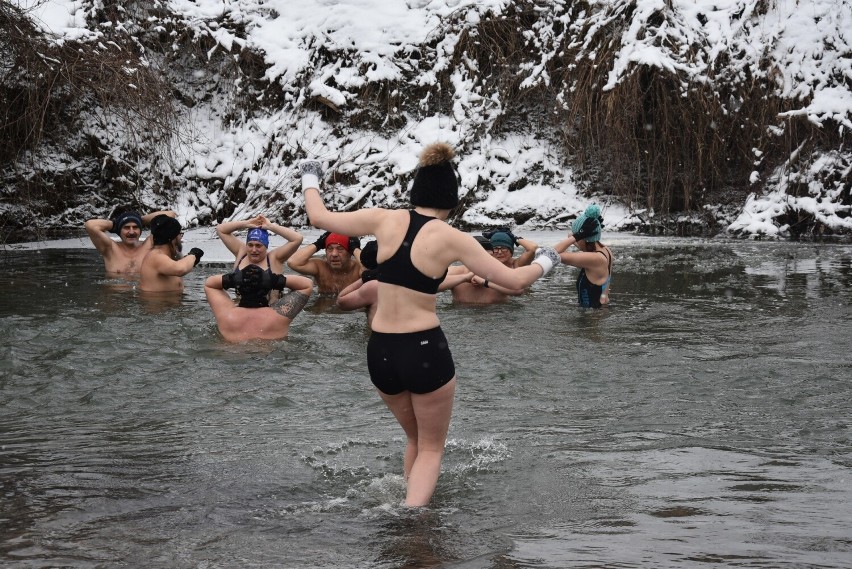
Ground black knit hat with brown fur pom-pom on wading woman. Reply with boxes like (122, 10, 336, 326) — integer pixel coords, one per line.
(409, 142, 459, 209)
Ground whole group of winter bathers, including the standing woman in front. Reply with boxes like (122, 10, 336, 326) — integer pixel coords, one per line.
(86, 143, 613, 506)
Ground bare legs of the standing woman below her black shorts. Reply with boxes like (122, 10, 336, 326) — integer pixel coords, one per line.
(380, 377, 456, 506)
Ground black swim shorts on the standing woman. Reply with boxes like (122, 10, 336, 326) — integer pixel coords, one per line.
(367, 326, 456, 395)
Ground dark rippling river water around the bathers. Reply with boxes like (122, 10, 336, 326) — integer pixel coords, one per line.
(0, 239, 852, 569)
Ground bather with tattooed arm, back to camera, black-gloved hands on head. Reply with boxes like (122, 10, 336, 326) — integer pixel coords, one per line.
(204, 264, 314, 342)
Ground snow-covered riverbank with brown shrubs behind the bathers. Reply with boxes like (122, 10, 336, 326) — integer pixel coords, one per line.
(0, 0, 852, 237)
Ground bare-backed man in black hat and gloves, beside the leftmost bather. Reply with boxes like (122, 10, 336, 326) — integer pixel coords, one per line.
(139, 216, 204, 292)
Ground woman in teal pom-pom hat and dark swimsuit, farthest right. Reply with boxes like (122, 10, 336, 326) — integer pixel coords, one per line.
(553, 204, 612, 308)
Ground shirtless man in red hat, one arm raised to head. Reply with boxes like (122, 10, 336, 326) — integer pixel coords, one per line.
(287, 231, 364, 296)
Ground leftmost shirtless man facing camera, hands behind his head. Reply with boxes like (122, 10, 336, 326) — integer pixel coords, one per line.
(85, 210, 176, 276)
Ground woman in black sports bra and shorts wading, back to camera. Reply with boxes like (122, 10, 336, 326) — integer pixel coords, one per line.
(300, 143, 559, 506)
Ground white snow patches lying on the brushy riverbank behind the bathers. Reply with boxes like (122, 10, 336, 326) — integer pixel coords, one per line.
(11, 0, 852, 236)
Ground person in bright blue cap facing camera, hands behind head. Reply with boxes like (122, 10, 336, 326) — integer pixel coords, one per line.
(216, 215, 303, 304)
